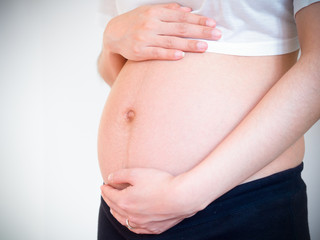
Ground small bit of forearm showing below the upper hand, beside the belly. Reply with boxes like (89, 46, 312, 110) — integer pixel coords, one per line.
(98, 48, 127, 87)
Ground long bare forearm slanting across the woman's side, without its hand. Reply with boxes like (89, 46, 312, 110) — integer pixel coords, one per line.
(180, 55, 320, 208)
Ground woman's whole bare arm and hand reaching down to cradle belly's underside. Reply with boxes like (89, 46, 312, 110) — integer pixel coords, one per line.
(101, 3, 320, 234)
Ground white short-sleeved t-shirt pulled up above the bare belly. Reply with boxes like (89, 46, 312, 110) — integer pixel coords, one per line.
(99, 0, 320, 56)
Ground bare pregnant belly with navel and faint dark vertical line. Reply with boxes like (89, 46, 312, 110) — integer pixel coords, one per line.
(98, 53, 304, 186)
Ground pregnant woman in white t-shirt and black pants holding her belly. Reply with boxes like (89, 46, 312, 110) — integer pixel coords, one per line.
(98, 0, 320, 240)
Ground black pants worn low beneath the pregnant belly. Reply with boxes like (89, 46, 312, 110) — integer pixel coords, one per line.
(98, 164, 310, 240)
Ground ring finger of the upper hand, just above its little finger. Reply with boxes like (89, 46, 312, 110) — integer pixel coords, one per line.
(152, 36, 208, 52)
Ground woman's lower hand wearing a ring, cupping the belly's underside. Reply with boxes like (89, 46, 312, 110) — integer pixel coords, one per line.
(101, 168, 200, 234)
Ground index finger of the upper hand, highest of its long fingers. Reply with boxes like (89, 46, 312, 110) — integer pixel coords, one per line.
(159, 8, 216, 28)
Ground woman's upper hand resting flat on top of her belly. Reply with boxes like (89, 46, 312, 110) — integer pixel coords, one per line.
(103, 3, 221, 61)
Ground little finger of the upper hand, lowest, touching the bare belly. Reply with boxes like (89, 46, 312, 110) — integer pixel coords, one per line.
(141, 47, 185, 60)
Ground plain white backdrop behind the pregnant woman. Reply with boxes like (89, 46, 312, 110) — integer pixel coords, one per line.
(0, 0, 320, 240)
